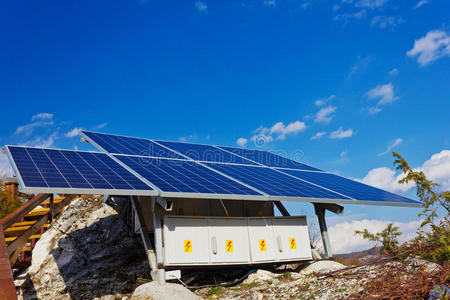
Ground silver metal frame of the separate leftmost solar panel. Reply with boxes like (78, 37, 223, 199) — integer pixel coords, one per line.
(4, 145, 158, 196)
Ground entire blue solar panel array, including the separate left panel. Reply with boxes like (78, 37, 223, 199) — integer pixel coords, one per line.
(2, 131, 420, 206)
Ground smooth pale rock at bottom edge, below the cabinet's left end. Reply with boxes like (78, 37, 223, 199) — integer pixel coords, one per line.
(132, 281, 200, 300)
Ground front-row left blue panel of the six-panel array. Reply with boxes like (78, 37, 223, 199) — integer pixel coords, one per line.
(114, 155, 261, 196)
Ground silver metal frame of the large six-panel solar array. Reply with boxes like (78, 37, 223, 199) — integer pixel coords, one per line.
(81, 131, 423, 207)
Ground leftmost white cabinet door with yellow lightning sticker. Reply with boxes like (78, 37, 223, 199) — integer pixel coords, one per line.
(163, 217, 209, 265)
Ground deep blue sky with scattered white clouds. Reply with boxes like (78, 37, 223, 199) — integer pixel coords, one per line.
(0, 0, 450, 251)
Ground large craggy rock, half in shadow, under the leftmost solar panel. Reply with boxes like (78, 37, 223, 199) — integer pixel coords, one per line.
(16, 197, 149, 299)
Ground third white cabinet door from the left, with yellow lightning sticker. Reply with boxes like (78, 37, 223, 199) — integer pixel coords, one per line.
(248, 218, 276, 263)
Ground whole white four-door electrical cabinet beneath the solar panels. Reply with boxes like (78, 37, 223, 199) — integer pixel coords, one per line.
(163, 216, 311, 266)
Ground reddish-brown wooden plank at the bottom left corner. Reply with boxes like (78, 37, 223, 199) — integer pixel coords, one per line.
(0, 225, 17, 300)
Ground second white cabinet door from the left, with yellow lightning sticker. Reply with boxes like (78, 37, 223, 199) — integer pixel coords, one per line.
(208, 218, 250, 264)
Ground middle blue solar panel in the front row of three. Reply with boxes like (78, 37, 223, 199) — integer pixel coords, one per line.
(207, 163, 349, 199)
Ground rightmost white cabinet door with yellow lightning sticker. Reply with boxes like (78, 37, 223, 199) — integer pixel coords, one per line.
(272, 217, 311, 260)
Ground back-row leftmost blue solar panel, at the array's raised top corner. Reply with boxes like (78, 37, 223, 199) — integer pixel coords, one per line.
(82, 131, 183, 158)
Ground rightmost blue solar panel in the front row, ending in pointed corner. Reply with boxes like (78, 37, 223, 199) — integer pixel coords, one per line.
(281, 170, 419, 204)
